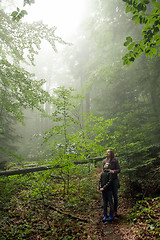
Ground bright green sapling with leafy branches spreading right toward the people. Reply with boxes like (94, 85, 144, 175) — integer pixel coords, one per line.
(42, 87, 114, 193)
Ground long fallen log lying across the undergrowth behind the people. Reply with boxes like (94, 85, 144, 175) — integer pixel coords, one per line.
(0, 157, 105, 176)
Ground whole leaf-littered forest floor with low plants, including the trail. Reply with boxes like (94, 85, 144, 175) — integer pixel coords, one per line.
(0, 170, 160, 240)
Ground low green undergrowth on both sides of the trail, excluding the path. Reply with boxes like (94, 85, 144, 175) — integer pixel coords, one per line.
(0, 167, 160, 240)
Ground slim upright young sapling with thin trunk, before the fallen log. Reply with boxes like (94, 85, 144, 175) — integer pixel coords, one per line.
(45, 87, 84, 193)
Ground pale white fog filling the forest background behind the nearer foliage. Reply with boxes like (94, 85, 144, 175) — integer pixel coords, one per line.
(2, 0, 160, 169)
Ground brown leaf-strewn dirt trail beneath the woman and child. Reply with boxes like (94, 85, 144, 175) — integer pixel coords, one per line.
(87, 194, 135, 240)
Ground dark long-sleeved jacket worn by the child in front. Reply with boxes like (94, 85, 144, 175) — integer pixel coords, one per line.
(99, 169, 113, 191)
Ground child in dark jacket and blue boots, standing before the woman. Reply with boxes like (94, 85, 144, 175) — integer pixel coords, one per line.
(99, 163, 113, 222)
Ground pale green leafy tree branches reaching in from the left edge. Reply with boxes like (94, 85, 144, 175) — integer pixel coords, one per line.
(0, 6, 64, 167)
